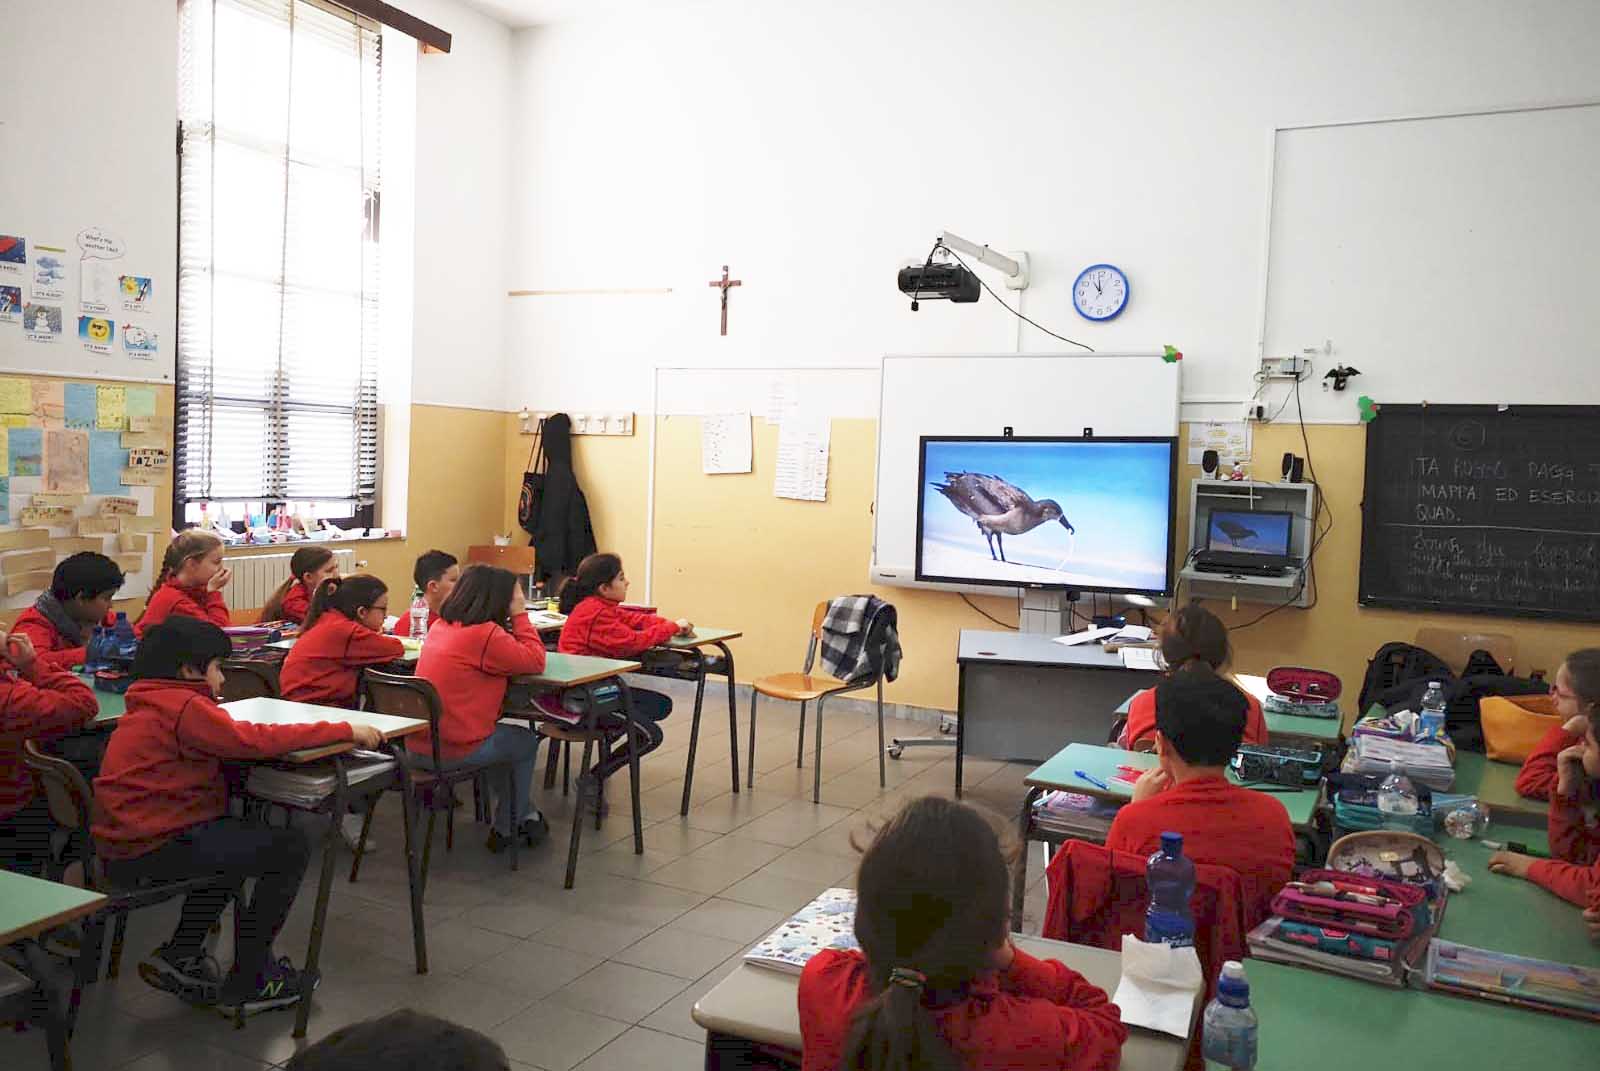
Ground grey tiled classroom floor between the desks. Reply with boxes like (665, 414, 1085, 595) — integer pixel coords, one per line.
(0, 682, 1043, 1071)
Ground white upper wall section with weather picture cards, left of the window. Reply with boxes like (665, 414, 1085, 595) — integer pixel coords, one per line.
(0, 3, 178, 383)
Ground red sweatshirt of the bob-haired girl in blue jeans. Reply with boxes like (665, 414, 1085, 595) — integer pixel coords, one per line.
(409, 613, 544, 762)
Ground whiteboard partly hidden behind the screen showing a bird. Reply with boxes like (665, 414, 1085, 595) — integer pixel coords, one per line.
(872, 354, 1182, 588)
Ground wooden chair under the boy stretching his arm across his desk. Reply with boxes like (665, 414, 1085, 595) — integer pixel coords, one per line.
(22, 740, 233, 985)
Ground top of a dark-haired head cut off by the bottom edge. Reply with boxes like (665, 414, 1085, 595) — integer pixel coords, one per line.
(283, 1009, 510, 1071)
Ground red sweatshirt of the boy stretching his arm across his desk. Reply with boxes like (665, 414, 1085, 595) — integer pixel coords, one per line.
(91, 680, 350, 860)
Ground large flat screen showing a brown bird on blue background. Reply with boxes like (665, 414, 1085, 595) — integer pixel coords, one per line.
(917, 435, 1178, 596)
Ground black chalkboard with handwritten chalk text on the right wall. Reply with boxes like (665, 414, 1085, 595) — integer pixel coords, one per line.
(1360, 405, 1600, 621)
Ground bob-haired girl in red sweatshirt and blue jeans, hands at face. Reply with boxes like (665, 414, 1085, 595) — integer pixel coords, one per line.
(405, 565, 550, 852)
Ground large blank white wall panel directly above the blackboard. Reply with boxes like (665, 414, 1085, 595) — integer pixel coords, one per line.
(1262, 104, 1600, 423)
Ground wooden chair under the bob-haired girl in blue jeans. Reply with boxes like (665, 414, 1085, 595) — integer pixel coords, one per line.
(363, 669, 526, 890)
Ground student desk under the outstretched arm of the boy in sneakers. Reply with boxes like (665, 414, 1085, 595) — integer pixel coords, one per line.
(222, 698, 427, 1037)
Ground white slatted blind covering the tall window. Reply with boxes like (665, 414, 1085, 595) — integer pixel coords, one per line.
(174, 0, 382, 517)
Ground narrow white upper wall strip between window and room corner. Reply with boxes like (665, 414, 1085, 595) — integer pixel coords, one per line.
(402, 0, 512, 408)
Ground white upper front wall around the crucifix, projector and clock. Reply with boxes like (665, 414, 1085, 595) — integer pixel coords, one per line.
(505, 0, 1600, 415)
